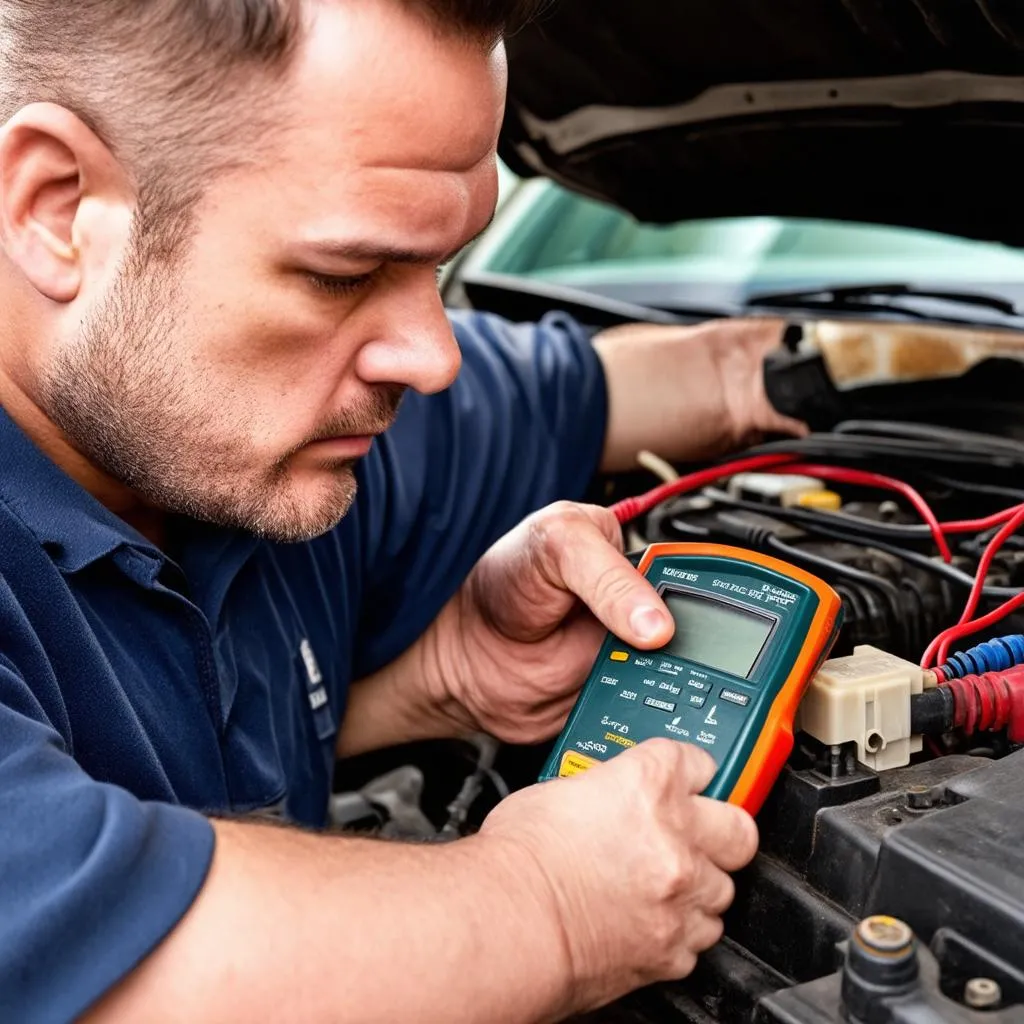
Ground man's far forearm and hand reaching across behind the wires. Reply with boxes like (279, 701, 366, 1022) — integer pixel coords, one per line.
(594, 319, 807, 472)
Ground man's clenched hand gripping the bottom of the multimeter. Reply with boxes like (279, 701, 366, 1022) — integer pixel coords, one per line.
(480, 739, 758, 1011)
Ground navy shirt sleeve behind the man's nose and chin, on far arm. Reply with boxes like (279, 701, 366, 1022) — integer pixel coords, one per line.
(353, 312, 607, 678)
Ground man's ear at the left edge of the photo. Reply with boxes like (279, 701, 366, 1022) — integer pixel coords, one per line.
(0, 103, 132, 302)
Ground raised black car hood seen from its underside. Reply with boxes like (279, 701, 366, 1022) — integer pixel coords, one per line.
(501, 0, 1024, 245)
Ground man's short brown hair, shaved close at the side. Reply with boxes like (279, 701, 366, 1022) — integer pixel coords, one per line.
(0, 0, 547, 249)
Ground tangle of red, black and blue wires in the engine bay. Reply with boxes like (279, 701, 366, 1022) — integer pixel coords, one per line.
(612, 421, 1024, 757)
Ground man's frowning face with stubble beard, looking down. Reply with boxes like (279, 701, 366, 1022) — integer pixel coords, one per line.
(39, 2, 505, 540)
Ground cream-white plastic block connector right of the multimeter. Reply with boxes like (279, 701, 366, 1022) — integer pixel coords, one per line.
(795, 644, 925, 771)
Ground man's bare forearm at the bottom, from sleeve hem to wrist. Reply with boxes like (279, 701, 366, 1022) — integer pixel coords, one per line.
(79, 822, 572, 1024)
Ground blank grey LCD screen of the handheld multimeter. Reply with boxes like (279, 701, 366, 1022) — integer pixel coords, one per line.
(662, 590, 775, 679)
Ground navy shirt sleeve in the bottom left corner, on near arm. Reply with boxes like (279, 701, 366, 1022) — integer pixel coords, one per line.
(0, 643, 214, 1024)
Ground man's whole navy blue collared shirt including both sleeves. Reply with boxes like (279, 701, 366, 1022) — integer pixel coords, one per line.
(0, 313, 606, 1022)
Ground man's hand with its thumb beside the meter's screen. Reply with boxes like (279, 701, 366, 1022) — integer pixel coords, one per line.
(425, 502, 675, 743)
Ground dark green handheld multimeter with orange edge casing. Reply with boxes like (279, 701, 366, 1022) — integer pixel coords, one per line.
(541, 544, 843, 814)
